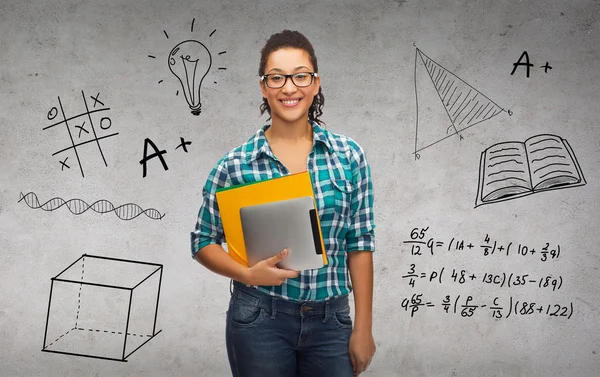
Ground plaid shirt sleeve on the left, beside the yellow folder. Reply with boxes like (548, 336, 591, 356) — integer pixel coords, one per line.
(190, 159, 228, 258)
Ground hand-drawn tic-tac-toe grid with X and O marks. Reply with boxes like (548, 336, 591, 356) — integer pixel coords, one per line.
(43, 90, 119, 177)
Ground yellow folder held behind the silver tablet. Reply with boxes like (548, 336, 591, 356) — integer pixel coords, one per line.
(215, 171, 327, 266)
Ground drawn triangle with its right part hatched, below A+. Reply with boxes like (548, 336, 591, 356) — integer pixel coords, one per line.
(414, 46, 512, 159)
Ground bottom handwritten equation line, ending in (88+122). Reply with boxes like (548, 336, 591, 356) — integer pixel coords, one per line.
(401, 293, 574, 319)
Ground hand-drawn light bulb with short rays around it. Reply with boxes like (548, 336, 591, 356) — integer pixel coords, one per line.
(148, 18, 227, 115)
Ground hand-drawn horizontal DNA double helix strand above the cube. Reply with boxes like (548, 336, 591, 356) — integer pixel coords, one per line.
(17, 192, 165, 220)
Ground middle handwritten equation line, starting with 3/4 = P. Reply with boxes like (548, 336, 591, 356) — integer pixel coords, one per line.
(402, 263, 563, 292)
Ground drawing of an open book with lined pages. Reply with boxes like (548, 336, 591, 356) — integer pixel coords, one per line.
(475, 134, 586, 207)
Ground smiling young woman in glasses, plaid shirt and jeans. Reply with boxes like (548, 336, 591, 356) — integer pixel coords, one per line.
(191, 30, 375, 377)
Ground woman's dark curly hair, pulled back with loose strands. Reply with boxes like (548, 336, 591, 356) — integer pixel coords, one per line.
(258, 30, 325, 124)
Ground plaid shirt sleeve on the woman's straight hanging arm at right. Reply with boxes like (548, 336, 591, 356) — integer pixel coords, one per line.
(346, 142, 375, 252)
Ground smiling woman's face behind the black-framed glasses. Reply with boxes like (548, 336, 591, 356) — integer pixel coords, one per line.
(260, 48, 320, 123)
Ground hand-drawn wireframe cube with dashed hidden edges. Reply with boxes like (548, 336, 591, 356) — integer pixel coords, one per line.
(42, 254, 163, 361)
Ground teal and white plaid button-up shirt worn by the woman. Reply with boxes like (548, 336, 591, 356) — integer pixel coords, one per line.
(191, 122, 375, 301)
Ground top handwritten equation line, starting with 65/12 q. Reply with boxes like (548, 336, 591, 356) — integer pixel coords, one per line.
(402, 227, 561, 262)
